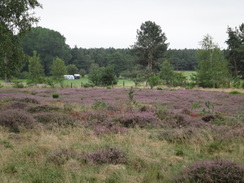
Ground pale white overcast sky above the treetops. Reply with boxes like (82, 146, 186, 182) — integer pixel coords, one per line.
(36, 0, 244, 49)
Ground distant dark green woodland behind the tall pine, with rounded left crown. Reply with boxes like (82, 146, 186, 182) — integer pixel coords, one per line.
(21, 27, 198, 76)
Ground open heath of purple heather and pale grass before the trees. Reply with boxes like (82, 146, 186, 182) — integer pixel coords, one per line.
(0, 88, 244, 183)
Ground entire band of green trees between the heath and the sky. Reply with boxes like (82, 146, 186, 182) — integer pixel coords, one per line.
(0, 0, 244, 87)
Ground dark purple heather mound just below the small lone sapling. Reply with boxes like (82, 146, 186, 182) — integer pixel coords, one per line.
(118, 112, 159, 128)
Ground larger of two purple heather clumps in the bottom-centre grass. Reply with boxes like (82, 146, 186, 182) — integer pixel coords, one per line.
(85, 147, 127, 165)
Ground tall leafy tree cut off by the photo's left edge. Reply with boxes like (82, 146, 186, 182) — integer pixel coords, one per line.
(0, 0, 41, 80)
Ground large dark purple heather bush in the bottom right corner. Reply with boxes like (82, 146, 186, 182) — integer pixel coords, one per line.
(175, 159, 244, 183)
